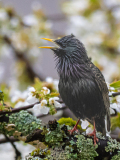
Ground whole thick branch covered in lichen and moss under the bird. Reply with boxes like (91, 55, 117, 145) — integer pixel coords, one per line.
(0, 111, 120, 160)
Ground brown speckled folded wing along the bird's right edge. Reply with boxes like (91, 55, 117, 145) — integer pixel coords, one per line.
(88, 61, 110, 131)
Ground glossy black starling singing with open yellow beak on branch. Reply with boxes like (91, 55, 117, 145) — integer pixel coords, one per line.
(39, 34, 110, 145)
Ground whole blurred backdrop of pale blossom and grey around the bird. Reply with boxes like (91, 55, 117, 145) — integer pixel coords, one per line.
(0, 0, 120, 160)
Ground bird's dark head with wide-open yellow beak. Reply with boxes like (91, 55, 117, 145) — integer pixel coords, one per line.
(39, 34, 87, 59)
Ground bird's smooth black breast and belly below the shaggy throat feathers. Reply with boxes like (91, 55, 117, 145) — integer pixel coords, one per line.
(59, 75, 106, 119)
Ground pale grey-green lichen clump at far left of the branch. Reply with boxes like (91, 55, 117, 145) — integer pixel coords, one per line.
(0, 111, 41, 136)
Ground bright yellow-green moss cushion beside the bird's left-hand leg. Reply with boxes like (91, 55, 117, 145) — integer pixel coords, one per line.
(58, 117, 85, 132)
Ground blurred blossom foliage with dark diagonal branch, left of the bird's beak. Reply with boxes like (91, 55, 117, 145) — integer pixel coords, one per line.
(0, 4, 52, 90)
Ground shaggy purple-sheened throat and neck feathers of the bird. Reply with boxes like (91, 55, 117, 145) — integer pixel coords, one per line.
(56, 56, 90, 81)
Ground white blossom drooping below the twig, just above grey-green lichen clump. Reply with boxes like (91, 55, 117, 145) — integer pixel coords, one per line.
(33, 99, 49, 114)
